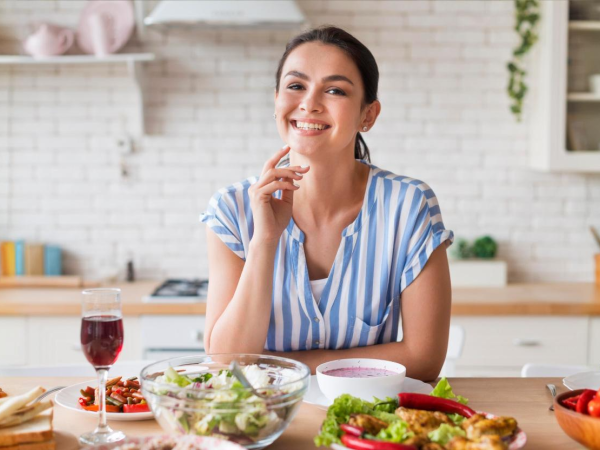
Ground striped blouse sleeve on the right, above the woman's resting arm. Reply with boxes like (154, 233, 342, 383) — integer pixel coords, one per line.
(400, 183, 454, 292)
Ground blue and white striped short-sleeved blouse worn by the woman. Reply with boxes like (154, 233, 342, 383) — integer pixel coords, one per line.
(200, 161, 454, 351)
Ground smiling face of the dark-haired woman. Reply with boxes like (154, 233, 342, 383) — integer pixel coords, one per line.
(275, 42, 376, 160)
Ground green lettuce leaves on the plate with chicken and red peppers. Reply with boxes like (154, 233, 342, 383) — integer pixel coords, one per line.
(314, 378, 468, 446)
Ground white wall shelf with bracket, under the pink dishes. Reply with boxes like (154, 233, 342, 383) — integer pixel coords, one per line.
(0, 53, 155, 136)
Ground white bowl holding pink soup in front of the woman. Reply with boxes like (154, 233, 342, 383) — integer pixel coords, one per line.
(317, 358, 406, 402)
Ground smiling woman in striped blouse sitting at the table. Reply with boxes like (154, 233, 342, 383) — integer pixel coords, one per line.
(201, 27, 453, 380)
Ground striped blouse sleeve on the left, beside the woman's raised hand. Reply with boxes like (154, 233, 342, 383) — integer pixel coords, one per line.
(200, 190, 246, 261)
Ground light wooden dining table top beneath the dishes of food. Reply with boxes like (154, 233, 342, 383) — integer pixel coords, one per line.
(0, 377, 583, 450)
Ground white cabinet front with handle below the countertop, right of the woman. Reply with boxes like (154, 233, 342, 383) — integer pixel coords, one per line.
(452, 316, 589, 376)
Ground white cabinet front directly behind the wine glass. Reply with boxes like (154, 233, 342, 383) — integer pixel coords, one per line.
(27, 316, 142, 365)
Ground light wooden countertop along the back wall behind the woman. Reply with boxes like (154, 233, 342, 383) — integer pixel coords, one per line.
(0, 281, 600, 316)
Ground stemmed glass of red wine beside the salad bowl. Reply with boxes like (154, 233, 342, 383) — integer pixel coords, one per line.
(79, 288, 125, 446)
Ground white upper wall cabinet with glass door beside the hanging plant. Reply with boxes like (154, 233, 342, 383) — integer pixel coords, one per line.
(525, 0, 600, 172)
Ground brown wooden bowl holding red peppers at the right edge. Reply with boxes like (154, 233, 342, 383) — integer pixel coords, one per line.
(554, 389, 600, 450)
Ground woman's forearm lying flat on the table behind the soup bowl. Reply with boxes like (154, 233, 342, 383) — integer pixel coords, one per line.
(263, 342, 445, 381)
